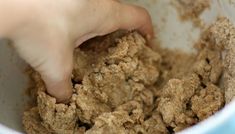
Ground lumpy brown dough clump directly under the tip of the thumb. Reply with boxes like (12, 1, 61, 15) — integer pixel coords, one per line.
(37, 92, 77, 134)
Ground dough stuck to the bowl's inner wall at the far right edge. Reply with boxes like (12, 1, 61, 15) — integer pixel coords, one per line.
(205, 18, 235, 103)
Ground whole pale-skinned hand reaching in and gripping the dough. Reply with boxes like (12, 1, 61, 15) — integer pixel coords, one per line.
(0, 0, 153, 102)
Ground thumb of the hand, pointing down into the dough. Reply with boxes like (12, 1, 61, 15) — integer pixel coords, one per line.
(14, 40, 73, 102)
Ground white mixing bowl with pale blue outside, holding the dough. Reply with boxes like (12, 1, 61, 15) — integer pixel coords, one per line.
(0, 0, 235, 134)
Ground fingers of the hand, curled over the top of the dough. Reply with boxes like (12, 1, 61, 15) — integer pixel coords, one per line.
(75, 0, 154, 47)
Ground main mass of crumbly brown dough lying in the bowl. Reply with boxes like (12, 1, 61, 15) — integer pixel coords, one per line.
(23, 18, 228, 134)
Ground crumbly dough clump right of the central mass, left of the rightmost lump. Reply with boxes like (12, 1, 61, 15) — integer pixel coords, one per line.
(157, 74, 200, 130)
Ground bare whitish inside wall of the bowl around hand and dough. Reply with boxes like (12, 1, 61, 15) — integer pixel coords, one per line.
(0, 0, 235, 132)
